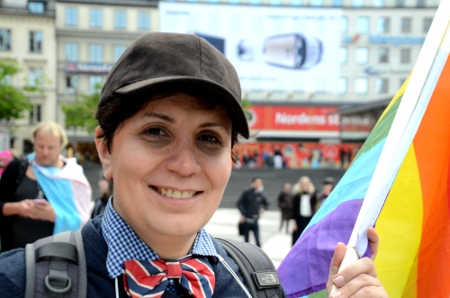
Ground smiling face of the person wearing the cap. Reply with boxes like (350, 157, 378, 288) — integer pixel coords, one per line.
(96, 94, 232, 247)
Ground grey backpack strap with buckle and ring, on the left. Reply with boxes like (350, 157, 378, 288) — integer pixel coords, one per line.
(25, 230, 87, 298)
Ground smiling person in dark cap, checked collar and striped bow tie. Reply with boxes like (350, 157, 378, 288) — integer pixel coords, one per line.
(0, 33, 382, 297)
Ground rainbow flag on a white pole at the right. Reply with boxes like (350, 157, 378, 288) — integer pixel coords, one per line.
(278, 0, 450, 298)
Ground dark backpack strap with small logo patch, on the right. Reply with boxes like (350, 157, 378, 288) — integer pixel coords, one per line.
(216, 238, 284, 298)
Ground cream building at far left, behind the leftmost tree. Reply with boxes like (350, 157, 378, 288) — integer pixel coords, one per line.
(0, 0, 57, 152)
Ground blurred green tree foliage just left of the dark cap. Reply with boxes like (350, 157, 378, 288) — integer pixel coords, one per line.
(62, 84, 102, 133)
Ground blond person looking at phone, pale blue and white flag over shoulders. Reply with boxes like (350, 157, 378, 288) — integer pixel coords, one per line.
(0, 121, 92, 252)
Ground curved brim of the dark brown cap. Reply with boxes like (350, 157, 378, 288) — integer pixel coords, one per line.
(114, 76, 250, 139)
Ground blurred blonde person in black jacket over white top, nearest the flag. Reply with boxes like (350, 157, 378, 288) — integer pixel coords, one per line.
(292, 176, 317, 246)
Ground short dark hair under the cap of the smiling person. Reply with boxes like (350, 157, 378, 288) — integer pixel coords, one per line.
(95, 88, 239, 163)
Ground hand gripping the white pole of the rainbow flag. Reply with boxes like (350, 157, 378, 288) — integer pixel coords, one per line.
(327, 228, 388, 298)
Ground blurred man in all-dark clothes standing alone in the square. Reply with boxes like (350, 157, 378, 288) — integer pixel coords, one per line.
(237, 177, 269, 247)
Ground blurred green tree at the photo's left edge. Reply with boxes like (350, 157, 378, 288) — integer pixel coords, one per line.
(0, 59, 35, 120)
